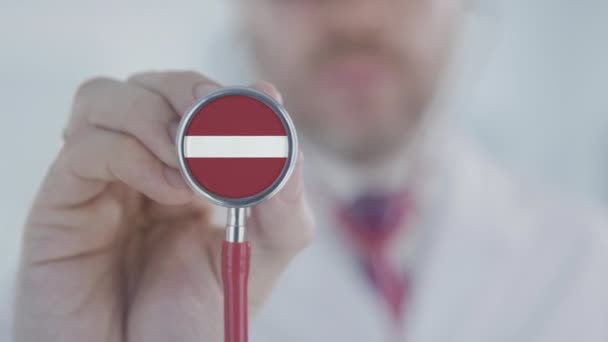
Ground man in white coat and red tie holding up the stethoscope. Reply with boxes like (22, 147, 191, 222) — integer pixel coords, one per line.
(10, 0, 608, 342)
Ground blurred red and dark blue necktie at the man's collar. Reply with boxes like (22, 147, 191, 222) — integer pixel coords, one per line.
(337, 192, 411, 324)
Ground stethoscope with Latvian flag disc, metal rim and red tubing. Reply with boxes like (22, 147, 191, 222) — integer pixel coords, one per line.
(176, 87, 298, 342)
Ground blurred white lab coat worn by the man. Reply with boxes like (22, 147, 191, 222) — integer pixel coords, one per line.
(251, 125, 608, 342)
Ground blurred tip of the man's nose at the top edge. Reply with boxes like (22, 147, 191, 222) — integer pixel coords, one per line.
(323, 0, 393, 37)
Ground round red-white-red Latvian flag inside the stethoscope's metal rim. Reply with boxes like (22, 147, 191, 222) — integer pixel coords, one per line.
(182, 95, 289, 198)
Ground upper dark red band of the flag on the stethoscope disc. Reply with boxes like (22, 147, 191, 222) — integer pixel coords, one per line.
(186, 95, 287, 136)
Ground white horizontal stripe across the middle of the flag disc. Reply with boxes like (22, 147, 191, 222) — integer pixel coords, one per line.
(184, 135, 288, 158)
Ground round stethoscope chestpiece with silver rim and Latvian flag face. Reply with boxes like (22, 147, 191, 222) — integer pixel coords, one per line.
(176, 87, 298, 208)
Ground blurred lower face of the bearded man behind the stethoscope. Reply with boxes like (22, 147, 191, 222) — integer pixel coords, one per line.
(241, 0, 462, 161)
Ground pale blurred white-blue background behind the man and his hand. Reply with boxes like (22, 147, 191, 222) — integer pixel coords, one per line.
(0, 0, 608, 340)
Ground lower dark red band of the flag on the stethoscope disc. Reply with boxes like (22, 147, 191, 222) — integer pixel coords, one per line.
(186, 158, 287, 198)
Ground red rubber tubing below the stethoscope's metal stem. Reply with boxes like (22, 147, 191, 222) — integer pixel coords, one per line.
(222, 241, 251, 342)
